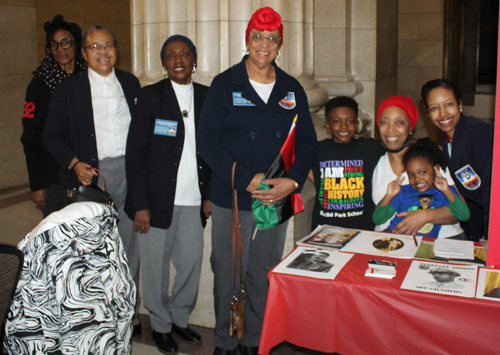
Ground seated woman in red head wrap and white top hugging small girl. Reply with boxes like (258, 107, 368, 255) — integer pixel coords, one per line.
(372, 96, 463, 238)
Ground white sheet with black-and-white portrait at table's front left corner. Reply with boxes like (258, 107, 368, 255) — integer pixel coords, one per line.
(273, 246, 353, 280)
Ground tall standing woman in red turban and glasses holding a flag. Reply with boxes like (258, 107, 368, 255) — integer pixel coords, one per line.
(198, 7, 317, 355)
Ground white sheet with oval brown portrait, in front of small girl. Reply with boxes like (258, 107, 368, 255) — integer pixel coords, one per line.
(341, 231, 417, 259)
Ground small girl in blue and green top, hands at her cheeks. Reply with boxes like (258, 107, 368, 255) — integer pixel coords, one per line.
(373, 138, 470, 238)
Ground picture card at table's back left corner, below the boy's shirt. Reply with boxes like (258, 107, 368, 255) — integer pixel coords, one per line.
(297, 225, 361, 249)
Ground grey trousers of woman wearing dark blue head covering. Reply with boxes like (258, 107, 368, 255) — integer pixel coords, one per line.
(138, 206, 203, 333)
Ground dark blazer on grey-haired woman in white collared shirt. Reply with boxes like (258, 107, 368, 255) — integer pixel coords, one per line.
(43, 68, 141, 189)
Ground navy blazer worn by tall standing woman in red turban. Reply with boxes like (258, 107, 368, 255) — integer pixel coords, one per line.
(198, 56, 318, 211)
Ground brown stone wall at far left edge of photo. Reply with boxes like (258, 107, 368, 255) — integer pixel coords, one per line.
(0, 0, 38, 189)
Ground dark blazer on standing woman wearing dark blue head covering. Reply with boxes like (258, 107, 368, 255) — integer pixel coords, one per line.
(125, 79, 210, 229)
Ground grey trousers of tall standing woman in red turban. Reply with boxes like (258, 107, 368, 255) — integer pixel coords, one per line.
(210, 204, 288, 350)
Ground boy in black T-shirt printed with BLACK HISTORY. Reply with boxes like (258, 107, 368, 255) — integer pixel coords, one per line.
(309, 96, 385, 230)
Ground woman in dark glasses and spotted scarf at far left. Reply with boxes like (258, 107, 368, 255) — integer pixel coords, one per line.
(21, 15, 87, 217)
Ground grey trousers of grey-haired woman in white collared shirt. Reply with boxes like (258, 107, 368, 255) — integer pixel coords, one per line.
(98, 156, 141, 316)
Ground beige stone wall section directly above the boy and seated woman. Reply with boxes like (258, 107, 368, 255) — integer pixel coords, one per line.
(314, 0, 398, 138)
